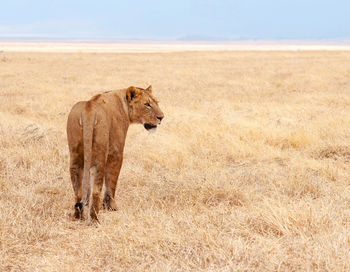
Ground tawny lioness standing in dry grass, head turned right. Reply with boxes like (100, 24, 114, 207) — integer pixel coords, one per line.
(67, 86, 164, 223)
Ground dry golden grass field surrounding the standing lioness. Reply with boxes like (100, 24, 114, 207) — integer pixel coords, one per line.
(0, 47, 350, 271)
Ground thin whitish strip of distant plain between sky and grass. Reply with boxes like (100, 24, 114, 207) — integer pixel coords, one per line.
(0, 40, 350, 53)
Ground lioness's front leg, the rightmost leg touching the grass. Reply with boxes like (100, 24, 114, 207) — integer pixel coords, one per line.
(103, 153, 123, 211)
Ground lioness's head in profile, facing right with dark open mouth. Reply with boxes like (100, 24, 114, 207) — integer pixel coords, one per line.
(126, 86, 164, 132)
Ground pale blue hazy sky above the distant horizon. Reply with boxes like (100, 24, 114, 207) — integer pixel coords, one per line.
(0, 0, 350, 40)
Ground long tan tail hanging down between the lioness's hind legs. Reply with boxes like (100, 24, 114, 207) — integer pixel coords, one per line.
(81, 108, 96, 205)
